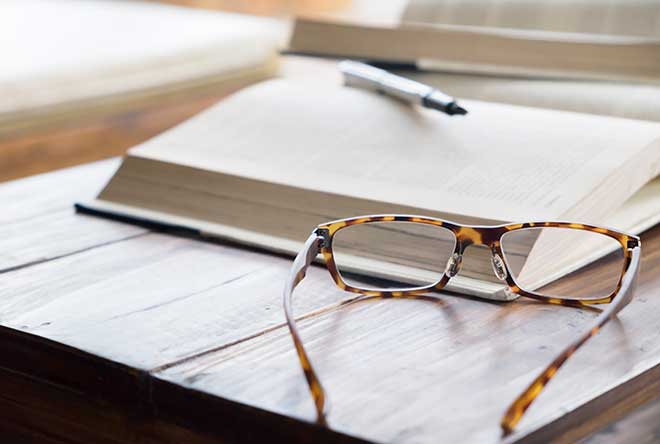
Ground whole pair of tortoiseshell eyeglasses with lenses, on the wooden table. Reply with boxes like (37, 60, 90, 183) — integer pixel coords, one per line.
(284, 215, 641, 435)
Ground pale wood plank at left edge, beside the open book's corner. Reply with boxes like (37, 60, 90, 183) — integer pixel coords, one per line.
(0, 159, 147, 273)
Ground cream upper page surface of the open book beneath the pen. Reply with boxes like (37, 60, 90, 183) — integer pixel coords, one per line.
(131, 80, 660, 222)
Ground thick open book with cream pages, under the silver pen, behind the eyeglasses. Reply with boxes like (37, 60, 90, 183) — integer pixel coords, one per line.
(78, 79, 660, 295)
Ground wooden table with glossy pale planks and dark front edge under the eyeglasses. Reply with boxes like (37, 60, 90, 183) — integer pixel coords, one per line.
(0, 160, 660, 443)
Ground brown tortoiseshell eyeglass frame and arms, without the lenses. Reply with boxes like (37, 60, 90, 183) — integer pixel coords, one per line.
(284, 215, 641, 435)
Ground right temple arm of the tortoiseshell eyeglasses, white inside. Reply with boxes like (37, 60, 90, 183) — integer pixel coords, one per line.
(500, 247, 641, 436)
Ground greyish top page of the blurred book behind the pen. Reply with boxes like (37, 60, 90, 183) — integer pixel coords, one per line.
(402, 0, 660, 38)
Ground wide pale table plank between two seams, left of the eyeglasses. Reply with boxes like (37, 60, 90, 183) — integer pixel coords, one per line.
(0, 234, 346, 370)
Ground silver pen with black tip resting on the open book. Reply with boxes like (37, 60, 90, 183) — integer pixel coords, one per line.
(339, 60, 467, 116)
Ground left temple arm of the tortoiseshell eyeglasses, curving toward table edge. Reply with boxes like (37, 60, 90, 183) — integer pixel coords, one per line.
(284, 233, 325, 423)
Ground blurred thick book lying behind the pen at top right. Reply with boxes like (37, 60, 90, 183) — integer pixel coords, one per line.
(291, 0, 660, 81)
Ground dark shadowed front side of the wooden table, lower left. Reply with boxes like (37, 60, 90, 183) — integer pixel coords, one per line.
(0, 327, 360, 444)
